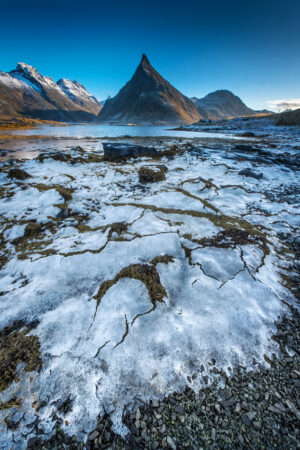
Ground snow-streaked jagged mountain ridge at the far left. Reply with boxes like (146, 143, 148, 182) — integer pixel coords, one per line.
(0, 63, 101, 122)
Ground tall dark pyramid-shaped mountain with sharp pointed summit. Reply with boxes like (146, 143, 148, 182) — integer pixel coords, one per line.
(97, 55, 201, 124)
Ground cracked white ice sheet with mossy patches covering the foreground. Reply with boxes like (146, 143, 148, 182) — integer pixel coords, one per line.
(0, 122, 299, 449)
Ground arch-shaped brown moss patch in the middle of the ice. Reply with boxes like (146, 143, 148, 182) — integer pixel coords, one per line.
(94, 264, 167, 308)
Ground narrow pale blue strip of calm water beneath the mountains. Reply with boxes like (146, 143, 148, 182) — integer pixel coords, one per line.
(0, 124, 230, 139)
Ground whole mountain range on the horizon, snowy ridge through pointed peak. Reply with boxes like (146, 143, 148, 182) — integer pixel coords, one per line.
(0, 59, 270, 124)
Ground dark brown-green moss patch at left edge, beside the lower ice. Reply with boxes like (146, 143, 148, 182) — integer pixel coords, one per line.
(0, 321, 42, 392)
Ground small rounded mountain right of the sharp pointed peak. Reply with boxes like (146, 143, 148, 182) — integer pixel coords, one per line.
(193, 89, 256, 119)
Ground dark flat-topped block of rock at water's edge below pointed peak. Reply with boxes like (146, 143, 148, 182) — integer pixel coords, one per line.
(103, 142, 159, 161)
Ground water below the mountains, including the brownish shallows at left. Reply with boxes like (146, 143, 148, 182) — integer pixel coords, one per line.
(0, 124, 234, 161)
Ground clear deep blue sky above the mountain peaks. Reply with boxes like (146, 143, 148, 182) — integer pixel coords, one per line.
(0, 0, 300, 110)
